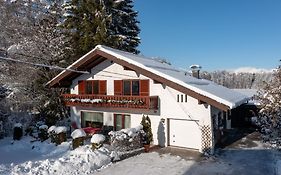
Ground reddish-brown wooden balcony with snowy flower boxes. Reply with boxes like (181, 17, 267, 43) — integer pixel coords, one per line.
(62, 94, 158, 110)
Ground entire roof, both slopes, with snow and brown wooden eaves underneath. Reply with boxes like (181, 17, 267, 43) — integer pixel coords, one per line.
(48, 46, 247, 111)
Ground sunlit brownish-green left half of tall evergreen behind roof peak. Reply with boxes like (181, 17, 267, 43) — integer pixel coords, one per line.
(62, 0, 110, 57)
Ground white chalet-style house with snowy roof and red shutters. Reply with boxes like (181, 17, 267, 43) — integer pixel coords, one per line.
(48, 45, 247, 152)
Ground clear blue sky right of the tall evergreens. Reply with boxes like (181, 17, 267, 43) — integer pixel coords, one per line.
(134, 0, 281, 71)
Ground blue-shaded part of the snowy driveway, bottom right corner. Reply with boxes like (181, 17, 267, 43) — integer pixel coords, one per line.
(186, 150, 281, 175)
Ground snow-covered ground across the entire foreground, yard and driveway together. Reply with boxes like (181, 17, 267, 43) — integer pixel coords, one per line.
(0, 137, 281, 175)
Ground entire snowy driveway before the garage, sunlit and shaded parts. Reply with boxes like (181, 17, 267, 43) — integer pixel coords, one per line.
(97, 150, 281, 175)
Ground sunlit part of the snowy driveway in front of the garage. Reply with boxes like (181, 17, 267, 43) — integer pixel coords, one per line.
(97, 152, 194, 175)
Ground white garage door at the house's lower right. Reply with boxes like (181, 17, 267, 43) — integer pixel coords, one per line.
(169, 119, 201, 149)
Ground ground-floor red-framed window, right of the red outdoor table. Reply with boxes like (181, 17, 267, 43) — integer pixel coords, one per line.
(114, 114, 131, 131)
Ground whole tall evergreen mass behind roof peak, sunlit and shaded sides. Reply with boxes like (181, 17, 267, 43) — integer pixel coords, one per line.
(62, 0, 140, 59)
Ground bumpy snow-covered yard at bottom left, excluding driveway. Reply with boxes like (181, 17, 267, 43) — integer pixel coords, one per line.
(0, 137, 111, 175)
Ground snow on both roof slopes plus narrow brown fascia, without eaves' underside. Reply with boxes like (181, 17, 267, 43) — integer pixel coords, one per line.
(48, 45, 248, 109)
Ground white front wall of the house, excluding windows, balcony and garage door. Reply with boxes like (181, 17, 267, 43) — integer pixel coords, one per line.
(68, 60, 214, 150)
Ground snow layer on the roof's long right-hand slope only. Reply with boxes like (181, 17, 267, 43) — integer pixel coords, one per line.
(96, 45, 248, 108)
